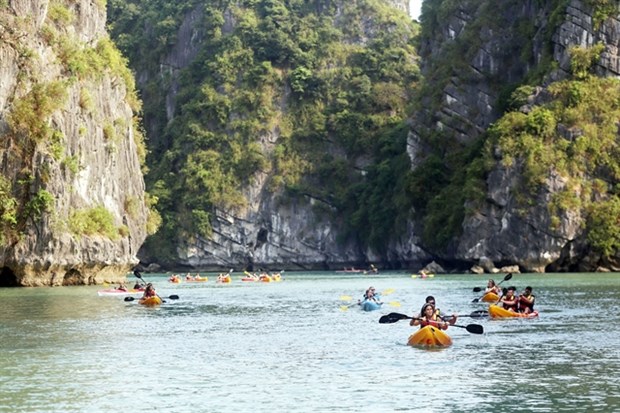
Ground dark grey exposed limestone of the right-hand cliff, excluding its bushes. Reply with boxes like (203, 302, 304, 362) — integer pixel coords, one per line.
(409, 0, 620, 272)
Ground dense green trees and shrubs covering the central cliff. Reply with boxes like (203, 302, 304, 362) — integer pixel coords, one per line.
(108, 0, 419, 259)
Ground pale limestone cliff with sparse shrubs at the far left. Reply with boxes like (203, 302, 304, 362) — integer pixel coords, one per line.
(0, 0, 149, 286)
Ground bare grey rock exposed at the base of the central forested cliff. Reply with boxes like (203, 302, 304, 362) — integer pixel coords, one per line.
(133, 0, 431, 270)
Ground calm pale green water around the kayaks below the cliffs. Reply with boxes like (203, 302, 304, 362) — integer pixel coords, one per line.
(0, 273, 620, 413)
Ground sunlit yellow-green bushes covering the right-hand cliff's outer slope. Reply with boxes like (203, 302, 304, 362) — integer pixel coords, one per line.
(487, 70, 620, 254)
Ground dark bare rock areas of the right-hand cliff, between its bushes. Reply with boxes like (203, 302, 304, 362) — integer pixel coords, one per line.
(409, 0, 620, 272)
